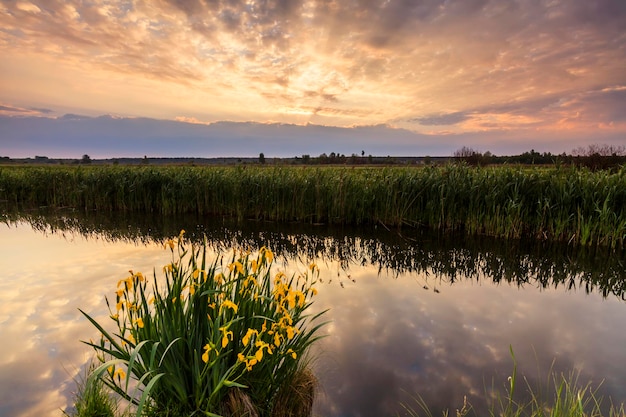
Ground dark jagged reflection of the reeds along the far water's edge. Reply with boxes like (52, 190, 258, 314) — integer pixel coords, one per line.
(5, 212, 626, 300)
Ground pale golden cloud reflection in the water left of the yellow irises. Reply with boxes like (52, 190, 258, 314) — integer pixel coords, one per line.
(0, 225, 168, 417)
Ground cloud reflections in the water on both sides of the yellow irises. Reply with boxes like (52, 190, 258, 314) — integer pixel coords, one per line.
(0, 223, 626, 417)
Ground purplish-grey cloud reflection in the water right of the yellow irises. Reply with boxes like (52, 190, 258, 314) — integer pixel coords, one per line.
(308, 268, 626, 417)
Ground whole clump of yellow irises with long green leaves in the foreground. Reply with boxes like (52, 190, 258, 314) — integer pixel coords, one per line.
(78, 231, 323, 417)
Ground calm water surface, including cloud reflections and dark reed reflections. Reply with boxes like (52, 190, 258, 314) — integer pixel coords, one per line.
(0, 216, 626, 417)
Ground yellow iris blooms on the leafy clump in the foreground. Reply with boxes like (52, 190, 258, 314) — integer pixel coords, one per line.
(107, 234, 319, 377)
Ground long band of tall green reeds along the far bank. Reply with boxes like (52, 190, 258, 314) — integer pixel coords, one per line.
(0, 165, 626, 247)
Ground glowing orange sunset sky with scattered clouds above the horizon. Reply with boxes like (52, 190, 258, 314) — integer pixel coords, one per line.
(0, 0, 626, 157)
